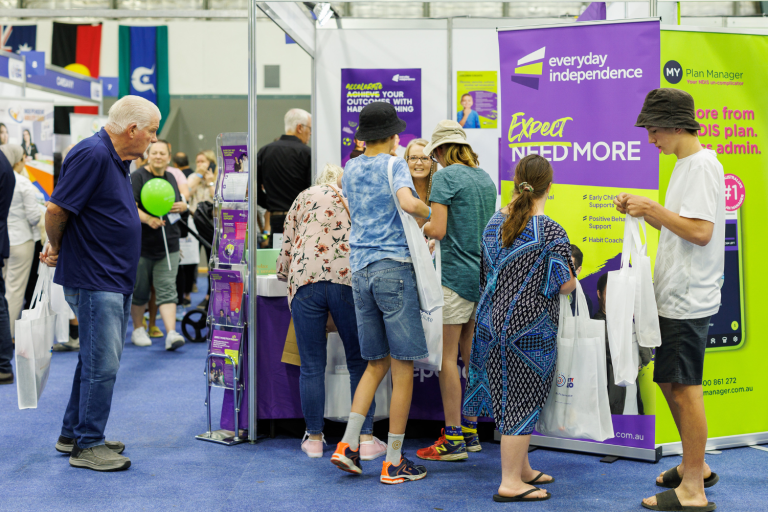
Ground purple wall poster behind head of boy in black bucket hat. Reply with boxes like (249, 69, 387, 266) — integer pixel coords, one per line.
(341, 69, 421, 167)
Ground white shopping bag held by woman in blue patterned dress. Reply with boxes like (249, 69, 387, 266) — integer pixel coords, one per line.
(536, 282, 614, 441)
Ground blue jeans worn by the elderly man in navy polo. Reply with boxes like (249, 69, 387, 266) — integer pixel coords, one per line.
(61, 287, 131, 449)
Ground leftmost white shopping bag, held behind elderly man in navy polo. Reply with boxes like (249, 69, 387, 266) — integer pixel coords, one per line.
(15, 263, 56, 409)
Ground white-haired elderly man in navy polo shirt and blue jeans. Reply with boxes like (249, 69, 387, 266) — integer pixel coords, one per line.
(40, 96, 160, 471)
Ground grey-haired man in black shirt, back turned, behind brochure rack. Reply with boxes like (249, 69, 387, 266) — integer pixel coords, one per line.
(256, 108, 312, 233)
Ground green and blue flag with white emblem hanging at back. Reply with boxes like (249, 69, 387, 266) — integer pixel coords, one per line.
(119, 26, 171, 131)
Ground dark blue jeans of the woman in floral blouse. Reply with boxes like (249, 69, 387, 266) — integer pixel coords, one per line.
(291, 281, 376, 435)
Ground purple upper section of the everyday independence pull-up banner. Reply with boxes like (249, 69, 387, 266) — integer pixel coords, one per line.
(499, 21, 660, 190)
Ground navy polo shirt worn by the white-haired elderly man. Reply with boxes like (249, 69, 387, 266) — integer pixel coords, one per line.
(51, 128, 141, 295)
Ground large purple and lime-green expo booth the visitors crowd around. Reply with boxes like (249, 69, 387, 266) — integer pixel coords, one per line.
(234, 1, 768, 461)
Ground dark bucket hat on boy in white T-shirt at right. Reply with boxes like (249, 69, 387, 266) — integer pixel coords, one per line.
(635, 88, 701, 130)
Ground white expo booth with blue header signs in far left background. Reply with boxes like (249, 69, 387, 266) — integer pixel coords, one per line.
(0, 48, 104, 200)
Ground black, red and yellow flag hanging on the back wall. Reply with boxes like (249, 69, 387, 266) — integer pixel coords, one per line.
(51, 21, 101, 135)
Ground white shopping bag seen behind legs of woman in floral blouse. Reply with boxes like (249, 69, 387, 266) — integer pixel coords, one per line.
(323, 332, 392, 422)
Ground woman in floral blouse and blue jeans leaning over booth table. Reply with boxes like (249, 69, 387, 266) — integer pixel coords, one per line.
(277, 164, 387, 460)
